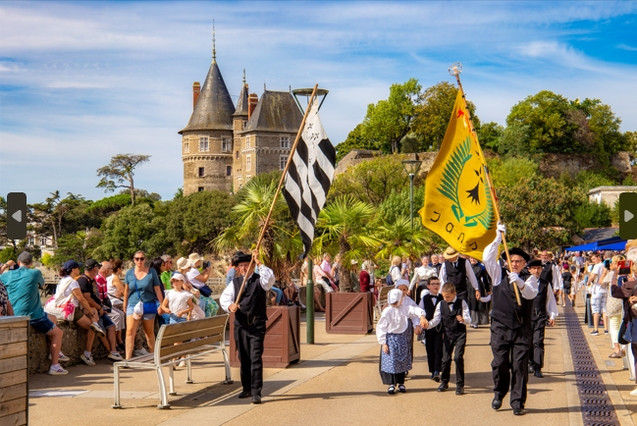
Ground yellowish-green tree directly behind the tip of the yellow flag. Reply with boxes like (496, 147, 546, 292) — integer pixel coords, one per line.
(412, 81, 480, 151)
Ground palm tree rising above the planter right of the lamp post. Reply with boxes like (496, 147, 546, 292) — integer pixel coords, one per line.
(313, 196, 378, 292)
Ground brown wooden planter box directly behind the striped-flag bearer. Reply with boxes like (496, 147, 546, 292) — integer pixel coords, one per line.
(230, 306, 301, 368)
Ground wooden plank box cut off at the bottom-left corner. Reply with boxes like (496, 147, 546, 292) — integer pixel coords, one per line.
(0, 317, 29, 425)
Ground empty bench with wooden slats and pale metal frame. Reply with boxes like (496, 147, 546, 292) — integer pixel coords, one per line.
(113, 314, 232, 408)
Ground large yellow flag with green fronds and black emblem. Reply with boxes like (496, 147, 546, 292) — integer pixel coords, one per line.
(419, 90, 496, 260)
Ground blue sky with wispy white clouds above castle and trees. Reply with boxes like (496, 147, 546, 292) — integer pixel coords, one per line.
(0, 1, 637, 203)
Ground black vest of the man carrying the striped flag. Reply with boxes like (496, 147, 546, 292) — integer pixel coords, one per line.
(232, 273, 268, 327)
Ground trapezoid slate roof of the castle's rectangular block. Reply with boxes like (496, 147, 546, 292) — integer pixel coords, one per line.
(245, 90, 303, 133)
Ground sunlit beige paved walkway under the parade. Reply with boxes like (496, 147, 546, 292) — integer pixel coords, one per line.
(29, 307, 637, 426)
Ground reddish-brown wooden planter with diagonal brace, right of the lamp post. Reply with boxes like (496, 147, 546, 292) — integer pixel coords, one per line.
(325, 292, 374, 334)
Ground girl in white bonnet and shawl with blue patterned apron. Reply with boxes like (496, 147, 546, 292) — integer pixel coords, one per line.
(376, 288, 428, 395)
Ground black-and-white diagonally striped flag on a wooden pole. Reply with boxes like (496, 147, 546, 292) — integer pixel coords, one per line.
(283, 99, 336, 258)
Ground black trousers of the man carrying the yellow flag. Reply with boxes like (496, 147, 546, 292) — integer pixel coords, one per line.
(490, 320, 531, 408)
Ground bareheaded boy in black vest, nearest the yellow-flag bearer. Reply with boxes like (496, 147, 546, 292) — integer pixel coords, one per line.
(428, 282, 471, 395)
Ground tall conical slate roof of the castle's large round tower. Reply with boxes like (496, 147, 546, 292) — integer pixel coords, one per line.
(179, 59, 235, 134)
